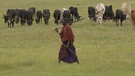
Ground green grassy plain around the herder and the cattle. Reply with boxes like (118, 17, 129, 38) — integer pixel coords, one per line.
(0, 0, 135, 76)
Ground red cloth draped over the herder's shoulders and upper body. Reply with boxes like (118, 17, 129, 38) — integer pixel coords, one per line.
(60, 24, 74, 43)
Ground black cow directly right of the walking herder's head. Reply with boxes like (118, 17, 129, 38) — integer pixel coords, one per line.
(69, 6, 81, 21)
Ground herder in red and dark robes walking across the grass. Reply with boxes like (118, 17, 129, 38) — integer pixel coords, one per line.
(55, 19, 79, 63)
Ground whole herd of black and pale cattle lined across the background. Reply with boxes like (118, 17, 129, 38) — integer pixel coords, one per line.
(3, 3, 135, 27)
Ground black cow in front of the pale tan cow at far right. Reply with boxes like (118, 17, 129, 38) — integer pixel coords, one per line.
(115, 9, 126, 26)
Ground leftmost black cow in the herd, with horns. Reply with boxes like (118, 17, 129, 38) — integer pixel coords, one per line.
(3, 9, 16, 27)
